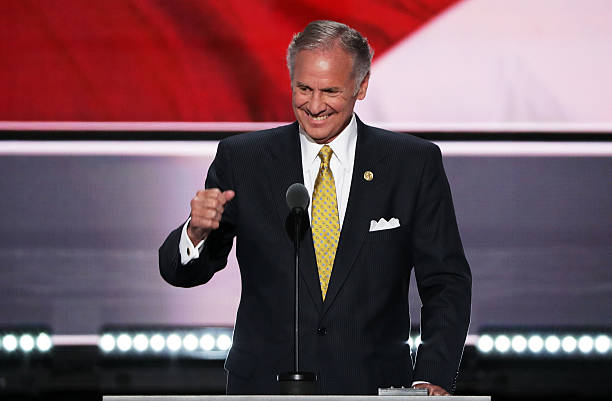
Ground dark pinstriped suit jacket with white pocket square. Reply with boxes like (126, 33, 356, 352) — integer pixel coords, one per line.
(159, 114, 471, 394)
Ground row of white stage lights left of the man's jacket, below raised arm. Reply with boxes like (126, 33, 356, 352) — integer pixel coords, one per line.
(99, 327, 232, 359)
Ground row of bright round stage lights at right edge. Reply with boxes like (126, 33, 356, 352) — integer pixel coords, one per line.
(476, 333, 612, 357)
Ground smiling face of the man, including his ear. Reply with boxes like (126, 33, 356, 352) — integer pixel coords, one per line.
(291, 46, 369, 144)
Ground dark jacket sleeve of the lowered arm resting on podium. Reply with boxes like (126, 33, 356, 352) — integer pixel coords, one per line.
(413, 146, 472, 392)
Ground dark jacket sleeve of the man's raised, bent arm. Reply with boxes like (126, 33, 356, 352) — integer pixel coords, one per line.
(159, 141, 238, 287)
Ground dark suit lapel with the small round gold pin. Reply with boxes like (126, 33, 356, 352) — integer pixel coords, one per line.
(323, 118, 385, 314)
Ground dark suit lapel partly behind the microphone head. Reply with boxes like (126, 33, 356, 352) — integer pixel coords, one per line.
(267, 122, 323, 311)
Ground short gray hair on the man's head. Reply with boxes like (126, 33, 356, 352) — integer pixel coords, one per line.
(287, 20, 374, 94)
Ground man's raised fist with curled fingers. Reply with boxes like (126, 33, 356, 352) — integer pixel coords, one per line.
(187, 188, 236, 244)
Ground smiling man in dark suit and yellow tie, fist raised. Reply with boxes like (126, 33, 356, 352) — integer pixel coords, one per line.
(159, 21, 471, 395)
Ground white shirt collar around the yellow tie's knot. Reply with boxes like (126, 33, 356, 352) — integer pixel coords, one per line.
(300, 113, 357, 168)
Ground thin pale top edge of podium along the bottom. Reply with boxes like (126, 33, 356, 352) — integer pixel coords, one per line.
(102, 395, 491, 401)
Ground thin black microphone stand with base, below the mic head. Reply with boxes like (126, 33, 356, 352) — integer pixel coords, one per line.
(276, 207, 317, 395)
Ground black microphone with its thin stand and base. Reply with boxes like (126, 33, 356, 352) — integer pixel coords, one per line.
(276, 182, 317, 395)
